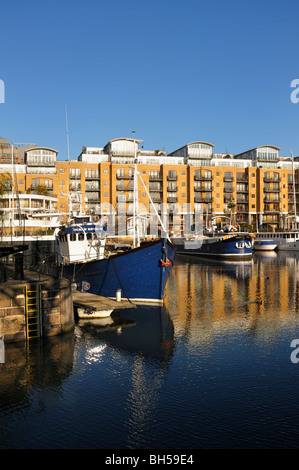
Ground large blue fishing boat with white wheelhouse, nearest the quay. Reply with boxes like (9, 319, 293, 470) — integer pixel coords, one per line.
(57, 218, 174, 303)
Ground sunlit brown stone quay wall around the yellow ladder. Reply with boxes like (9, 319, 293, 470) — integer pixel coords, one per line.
(0, 279, 74, 343)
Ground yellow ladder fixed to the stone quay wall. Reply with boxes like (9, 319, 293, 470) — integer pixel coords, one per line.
(25, 284, 41, 341)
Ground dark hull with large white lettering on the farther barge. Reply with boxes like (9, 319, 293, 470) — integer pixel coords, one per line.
(177, 235, 252, 260)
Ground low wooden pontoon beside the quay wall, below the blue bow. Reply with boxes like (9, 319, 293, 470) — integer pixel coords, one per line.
(72, 290, 136, 310)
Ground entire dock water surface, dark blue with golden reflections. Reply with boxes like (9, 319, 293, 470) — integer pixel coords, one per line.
(0, 254, 299, 449)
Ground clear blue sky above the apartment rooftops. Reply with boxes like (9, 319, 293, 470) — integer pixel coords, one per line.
(0, 0, 299, 160)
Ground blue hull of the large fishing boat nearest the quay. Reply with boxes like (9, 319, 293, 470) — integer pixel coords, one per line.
(61, 239, 174, 304)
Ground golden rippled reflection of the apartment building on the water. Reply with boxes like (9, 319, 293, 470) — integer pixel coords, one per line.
(165, 253, 299, 346)
